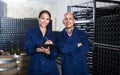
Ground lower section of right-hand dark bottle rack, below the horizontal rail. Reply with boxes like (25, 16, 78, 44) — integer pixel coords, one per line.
(93, 45, 120, 75)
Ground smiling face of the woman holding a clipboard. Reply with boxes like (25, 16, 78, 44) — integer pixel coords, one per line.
(38, 13, 50, 28)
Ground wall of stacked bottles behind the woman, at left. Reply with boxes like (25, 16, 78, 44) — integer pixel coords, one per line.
(0, 17, 38, 51)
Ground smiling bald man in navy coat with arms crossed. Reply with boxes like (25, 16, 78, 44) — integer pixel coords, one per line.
(58, 12, 90, 75)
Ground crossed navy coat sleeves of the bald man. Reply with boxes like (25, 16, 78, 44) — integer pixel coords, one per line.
(57, 32, 90, 54)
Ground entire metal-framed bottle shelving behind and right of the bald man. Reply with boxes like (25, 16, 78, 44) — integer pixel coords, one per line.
(68, 0, 120, 75)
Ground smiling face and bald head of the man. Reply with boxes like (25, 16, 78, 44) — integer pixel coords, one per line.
(63, 13, 74, 28)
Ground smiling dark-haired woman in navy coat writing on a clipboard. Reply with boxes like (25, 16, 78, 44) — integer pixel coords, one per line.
(24, 10, 59, 75)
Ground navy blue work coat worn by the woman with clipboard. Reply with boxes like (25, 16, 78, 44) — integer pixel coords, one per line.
(24, 27, 59, 75)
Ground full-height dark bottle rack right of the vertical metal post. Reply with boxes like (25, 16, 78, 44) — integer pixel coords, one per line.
(93, 0, 120, 75)
